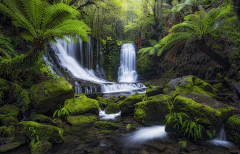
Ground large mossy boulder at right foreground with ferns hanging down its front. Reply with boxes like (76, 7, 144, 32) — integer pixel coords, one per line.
(165, 94, 233, 140)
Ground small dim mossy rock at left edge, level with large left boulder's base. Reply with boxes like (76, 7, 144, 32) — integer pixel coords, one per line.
(0, 104, 20, 117)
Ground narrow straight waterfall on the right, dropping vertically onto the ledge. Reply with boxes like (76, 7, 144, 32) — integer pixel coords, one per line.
(118, 44, 138, 82)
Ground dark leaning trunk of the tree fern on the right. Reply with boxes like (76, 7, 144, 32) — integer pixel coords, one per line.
(197, 38, 231, 70)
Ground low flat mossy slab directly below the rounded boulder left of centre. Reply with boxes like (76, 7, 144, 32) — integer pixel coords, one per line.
(66, 115, 97, 126)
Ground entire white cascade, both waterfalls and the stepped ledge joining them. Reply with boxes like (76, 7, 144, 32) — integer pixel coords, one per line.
(46, 37, 146, 93)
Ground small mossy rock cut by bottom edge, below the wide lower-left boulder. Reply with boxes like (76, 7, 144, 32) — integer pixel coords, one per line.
(31, 140, 52, 154)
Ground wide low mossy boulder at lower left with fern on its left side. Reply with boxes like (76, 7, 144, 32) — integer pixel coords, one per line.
(18, 121, 64, 143)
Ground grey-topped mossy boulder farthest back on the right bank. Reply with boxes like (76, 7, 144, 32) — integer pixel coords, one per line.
(163, 75, 216, 98)
